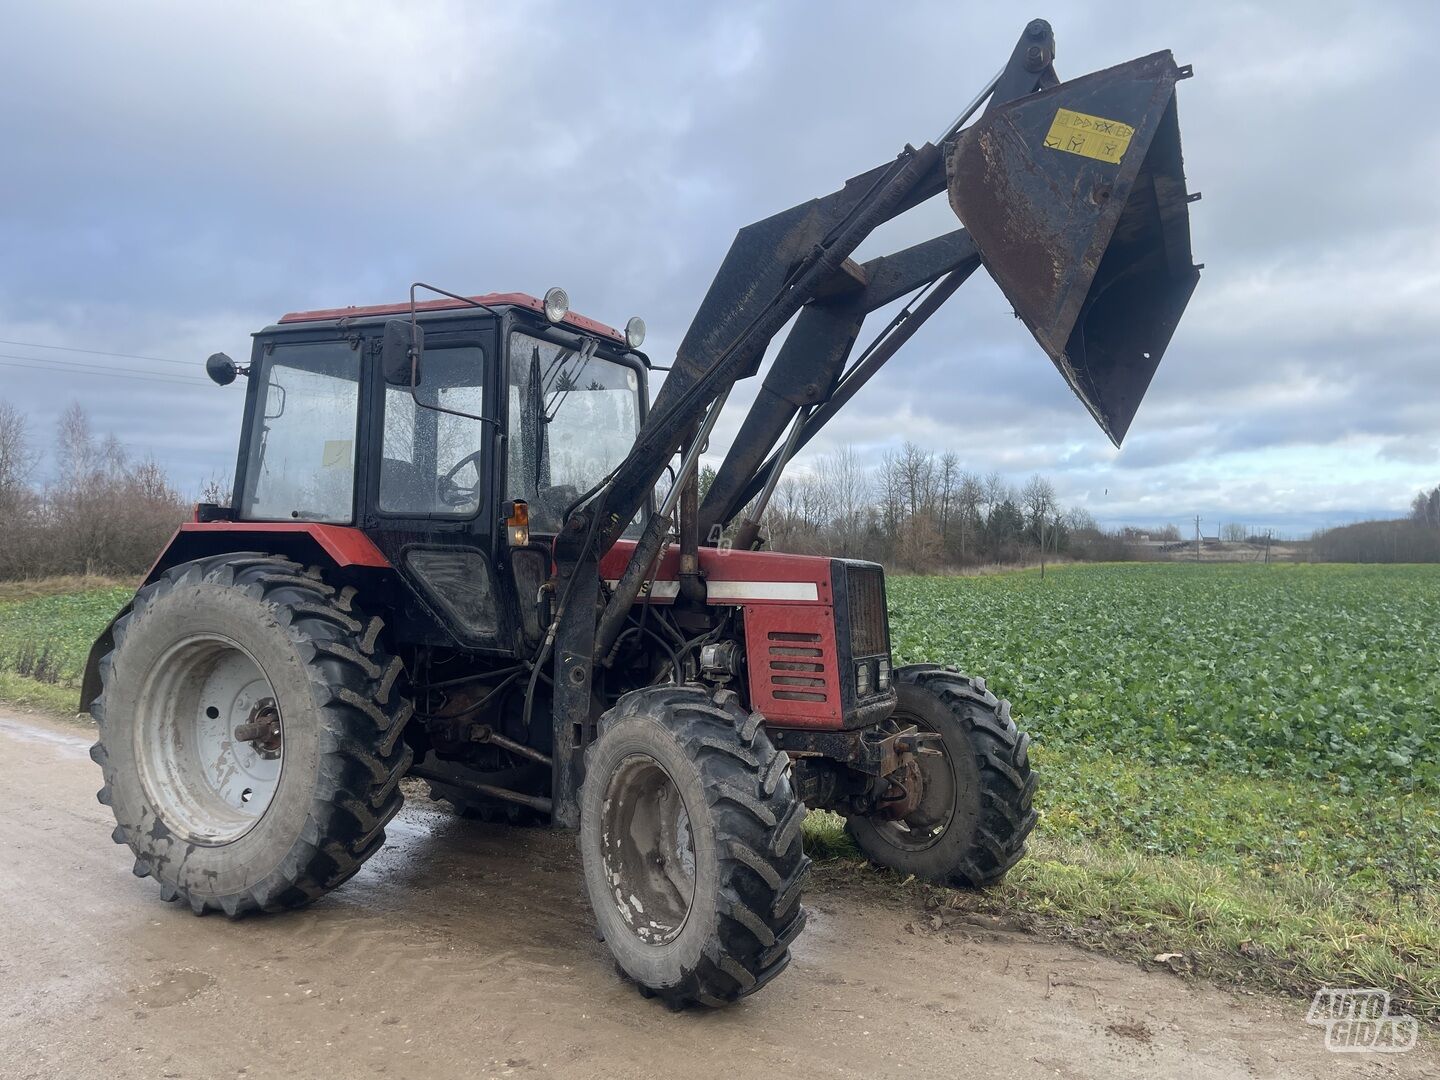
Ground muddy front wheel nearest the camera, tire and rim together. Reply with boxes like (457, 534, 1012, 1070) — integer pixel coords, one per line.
(580, 685, 809, 1008)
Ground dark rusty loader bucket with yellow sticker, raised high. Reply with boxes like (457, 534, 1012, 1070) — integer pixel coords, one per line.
(948, 52, 1200, 446)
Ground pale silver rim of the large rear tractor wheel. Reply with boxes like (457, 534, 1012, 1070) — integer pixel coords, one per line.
(135, 635, 285, 845)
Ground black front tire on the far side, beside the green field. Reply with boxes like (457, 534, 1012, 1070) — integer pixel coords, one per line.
(847, 664, 1035, 888)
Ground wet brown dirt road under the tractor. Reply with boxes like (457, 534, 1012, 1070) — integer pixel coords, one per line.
(0, 711, 1440, 1080)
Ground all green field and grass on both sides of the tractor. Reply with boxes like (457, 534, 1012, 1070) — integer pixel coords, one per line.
(0, 564, 1440, 1020)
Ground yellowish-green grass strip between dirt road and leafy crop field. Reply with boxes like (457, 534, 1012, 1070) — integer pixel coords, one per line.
(805, 750, 1440, 1024)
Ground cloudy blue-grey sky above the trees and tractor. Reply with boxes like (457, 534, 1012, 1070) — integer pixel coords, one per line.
(0, 0, 1440, 533)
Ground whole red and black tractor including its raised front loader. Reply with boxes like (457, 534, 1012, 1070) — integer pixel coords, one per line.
(84, 20, 1200, 1005)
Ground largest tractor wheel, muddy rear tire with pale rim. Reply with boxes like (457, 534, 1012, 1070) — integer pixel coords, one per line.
(91, 553, 413, 917)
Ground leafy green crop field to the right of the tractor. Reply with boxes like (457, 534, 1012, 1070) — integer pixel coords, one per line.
(890, 564, 1440, 881)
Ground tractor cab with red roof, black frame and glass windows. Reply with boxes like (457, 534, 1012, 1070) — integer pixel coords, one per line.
(212, 289, 649, 652)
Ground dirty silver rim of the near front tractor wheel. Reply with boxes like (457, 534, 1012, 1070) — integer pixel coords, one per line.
(600, 755, 696, 945)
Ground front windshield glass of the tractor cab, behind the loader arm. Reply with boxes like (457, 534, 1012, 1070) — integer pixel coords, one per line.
(505, 331, 639, 533)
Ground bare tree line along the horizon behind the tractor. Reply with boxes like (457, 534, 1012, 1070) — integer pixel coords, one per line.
(0, 402, 1440, 579)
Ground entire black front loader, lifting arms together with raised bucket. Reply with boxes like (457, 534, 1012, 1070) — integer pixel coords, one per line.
(544, 19, 1200, 824)
